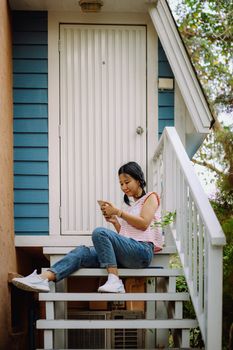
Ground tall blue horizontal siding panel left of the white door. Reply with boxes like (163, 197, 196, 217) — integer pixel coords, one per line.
(12, 11, 49, 235)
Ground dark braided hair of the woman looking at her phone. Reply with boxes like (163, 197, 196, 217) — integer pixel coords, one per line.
(118, 162, 146, 205)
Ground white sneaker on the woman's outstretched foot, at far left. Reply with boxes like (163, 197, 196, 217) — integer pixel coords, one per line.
(12, 270, 50, 292)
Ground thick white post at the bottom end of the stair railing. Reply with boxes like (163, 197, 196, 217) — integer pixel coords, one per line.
(205, 242, 223, 350)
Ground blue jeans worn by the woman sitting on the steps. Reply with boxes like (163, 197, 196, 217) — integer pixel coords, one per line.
(49, 227, 153, 281)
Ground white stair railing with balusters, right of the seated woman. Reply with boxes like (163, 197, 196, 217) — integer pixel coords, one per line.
(154, 127, 225, 350)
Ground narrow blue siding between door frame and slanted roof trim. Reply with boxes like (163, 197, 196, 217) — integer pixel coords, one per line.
(158, 41, 174, 137)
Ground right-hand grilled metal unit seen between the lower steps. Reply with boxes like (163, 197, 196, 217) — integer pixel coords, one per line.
(111, 311, 144, 349)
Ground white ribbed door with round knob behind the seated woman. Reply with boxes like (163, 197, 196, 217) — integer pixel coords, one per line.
(60, 24, 147, 234)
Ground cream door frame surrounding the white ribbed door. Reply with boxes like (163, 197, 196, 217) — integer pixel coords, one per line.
(48, 11, 158, 236)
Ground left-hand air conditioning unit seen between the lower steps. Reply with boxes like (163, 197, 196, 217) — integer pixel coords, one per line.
(67, 309, 111, 349)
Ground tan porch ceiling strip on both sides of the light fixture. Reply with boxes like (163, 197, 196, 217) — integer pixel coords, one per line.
(9, 0, 157, 12)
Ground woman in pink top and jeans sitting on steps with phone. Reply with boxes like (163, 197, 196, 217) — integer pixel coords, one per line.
(12, 162, 162, 293)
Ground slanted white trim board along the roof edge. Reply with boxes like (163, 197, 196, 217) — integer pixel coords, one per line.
(149, 0, 213, 134)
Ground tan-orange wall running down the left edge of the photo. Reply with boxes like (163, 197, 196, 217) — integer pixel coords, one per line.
(0, 0, 16, 349)
